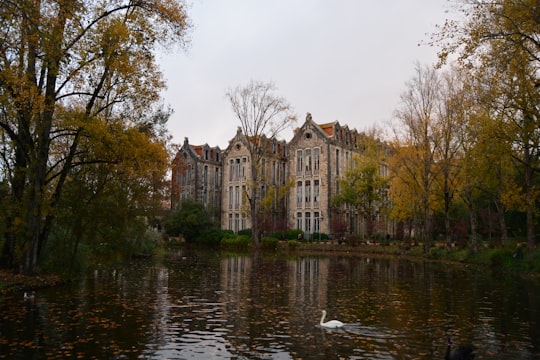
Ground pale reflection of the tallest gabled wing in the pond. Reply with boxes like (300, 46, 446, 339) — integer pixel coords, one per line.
(288, 257, 330, 305)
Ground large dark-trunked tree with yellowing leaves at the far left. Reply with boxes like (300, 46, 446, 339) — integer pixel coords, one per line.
(0, 0, 188, 274)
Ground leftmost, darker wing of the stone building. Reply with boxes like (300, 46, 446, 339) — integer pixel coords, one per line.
(171, 138, 222, 220)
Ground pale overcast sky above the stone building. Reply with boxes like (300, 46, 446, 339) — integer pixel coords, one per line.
(159, 0, 452, 149)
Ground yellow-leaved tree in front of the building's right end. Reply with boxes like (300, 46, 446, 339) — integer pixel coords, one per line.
(332, 134, 388, 239)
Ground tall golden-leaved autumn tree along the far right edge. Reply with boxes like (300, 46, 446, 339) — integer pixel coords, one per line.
(433, 0, 540, 251)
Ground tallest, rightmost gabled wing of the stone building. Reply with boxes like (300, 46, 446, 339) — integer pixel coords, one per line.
(288, 113, 364, 239)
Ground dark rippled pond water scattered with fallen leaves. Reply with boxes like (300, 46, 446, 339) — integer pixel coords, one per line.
(0, 249, 540, 359)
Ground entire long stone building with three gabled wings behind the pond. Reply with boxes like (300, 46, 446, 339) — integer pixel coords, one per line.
(171, 113, 390, 239)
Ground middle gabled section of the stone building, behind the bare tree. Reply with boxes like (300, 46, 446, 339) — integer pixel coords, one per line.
(221, 128, 287, 233)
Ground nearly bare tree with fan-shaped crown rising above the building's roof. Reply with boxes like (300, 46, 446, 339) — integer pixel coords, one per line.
(226, 81, 296, 246)
